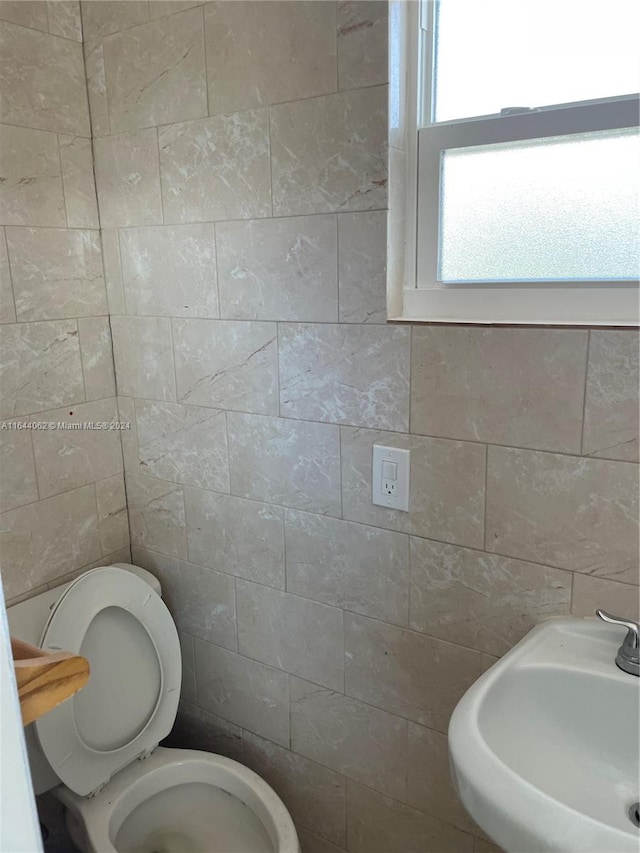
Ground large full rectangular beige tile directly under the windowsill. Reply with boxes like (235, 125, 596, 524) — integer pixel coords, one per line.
(411, 326, 588, 453)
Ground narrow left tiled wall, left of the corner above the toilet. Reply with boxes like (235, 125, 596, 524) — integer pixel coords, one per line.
(0, 0, 129, 601)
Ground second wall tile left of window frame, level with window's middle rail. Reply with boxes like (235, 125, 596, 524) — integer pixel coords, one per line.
(159, 109, 271, 223)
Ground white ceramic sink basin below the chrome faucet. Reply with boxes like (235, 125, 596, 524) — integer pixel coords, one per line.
(449, 619, 640, 853)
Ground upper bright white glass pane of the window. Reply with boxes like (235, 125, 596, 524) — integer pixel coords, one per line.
(433, 0, 640, 121)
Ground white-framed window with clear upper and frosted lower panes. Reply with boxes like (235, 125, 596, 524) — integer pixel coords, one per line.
(390, 0, 640, 325)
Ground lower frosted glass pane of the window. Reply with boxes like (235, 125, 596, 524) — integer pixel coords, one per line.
(438, 129, 640, 282)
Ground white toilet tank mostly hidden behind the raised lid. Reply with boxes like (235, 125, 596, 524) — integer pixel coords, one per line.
(7, 563, 162, 795)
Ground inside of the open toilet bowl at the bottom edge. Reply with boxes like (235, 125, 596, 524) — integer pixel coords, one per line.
(114, 782, 275, 853)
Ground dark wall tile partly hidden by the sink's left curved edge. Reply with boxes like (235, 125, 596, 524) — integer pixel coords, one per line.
(407, 723, 478, 833)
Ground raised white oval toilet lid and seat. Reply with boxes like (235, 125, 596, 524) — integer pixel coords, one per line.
(35, 567, 181, 795)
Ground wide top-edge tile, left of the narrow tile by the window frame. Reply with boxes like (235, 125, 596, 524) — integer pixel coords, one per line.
(205, 0, 336, 115)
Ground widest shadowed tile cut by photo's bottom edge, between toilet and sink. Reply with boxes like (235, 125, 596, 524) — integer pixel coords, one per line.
(347, 782, 473, 853)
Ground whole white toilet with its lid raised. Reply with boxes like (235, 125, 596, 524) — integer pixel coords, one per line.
(8, 563, 300, 853)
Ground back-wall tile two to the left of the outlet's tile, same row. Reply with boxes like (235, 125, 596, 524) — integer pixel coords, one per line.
(136, 400, 229, 492)
